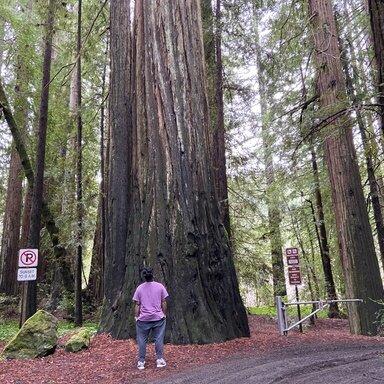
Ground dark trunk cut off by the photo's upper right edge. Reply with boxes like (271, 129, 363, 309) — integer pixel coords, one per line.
(368, 0, 384, 135)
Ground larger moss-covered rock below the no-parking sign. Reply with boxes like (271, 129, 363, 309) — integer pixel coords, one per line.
(0, 310, 58, 359)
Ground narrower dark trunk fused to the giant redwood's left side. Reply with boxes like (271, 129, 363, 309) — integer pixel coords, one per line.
(101, 0, 132, 330)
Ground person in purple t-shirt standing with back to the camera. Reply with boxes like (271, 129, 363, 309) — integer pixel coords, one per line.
(133, 267, 169, 369)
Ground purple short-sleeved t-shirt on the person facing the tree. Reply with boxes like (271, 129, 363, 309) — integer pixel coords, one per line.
(133, 281, 168, 321)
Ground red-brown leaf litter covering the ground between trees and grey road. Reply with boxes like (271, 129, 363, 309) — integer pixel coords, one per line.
(0, 316, 383, 384)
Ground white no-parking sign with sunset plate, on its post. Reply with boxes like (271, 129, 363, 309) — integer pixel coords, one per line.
(17, 249, 39, 326)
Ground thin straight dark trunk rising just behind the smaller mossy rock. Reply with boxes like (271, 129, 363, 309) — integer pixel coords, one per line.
(75, 0, 84, 325)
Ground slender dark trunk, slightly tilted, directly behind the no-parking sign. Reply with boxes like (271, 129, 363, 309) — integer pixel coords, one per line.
(21, 0, 56, 323)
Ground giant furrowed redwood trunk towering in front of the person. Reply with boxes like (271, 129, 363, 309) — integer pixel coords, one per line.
(102, 0, 249, 343)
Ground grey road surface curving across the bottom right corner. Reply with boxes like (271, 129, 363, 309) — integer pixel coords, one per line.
(149, 343, 384, 384)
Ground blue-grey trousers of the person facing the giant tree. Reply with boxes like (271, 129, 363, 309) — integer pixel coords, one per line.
(136, 317, 166, 361)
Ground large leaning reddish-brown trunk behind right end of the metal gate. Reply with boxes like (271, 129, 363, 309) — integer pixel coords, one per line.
(309, 0, 384, 334)
